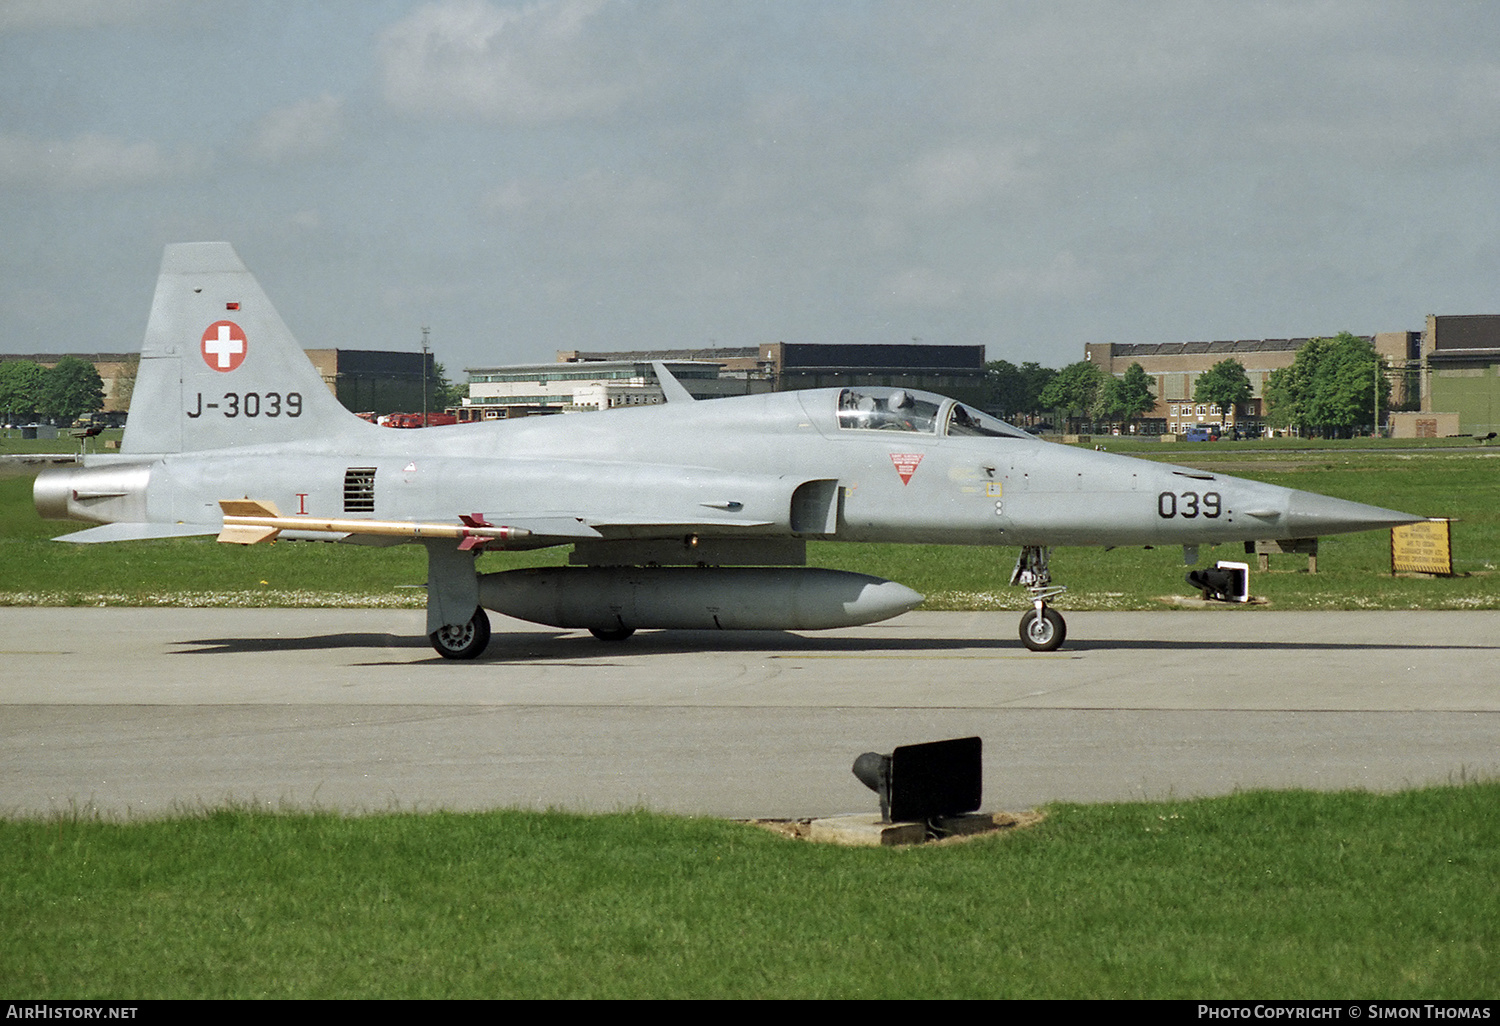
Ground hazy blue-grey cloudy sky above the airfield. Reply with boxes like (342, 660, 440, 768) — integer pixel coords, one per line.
(0, 0, 1500, 371)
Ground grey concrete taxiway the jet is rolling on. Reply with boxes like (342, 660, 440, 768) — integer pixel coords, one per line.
(0, 608, 1500, 818)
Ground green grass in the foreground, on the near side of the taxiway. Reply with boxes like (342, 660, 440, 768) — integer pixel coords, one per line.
(0, 785, 1500, 999)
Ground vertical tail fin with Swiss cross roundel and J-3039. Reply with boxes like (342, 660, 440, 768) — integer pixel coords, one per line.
(120, 243, 374, 453)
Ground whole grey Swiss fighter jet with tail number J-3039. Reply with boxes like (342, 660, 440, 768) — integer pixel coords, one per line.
(35, 243, 1422, 659)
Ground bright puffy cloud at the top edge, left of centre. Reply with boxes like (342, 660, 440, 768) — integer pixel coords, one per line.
(380, 0, 633, 125)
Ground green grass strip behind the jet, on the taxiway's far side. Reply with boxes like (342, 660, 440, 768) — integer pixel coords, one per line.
(0, 440, 1500, 611)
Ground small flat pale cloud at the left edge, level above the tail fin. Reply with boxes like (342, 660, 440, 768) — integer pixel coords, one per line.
(0, 134, 209, 192)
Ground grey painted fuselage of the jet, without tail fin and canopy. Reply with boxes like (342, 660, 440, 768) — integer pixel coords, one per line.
(85, 389, 1413, 546)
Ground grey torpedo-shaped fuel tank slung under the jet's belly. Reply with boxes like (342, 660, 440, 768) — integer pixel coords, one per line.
(479, 567, 923, 632)
